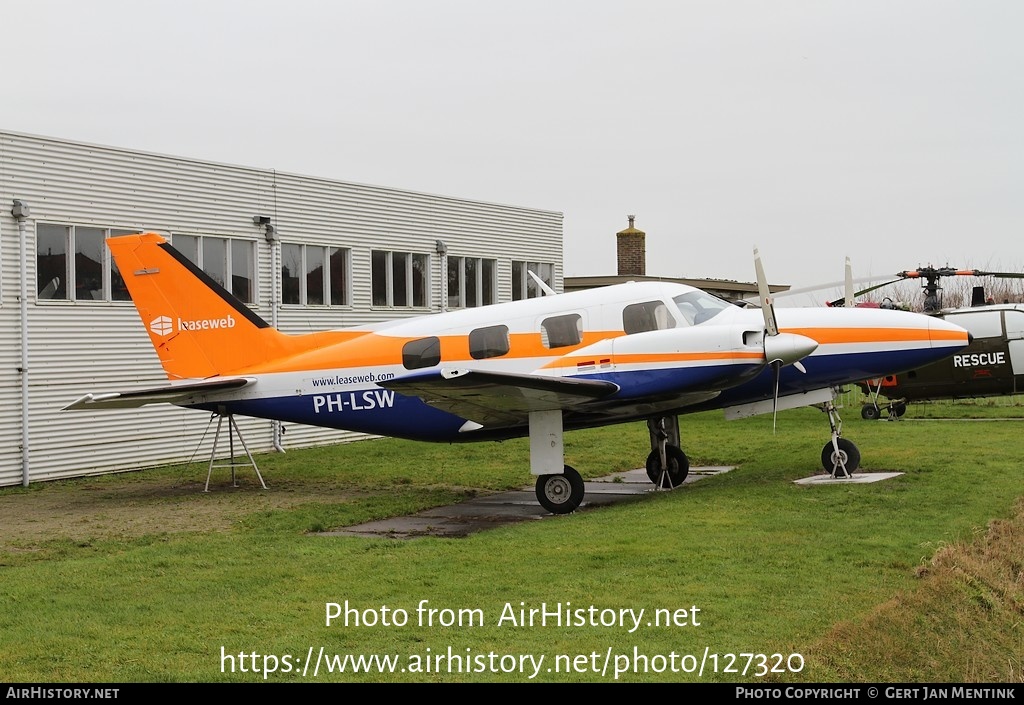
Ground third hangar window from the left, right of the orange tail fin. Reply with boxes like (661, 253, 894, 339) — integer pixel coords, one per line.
(281, 244, 349, 306)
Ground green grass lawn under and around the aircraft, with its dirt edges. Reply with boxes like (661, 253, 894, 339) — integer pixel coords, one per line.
(0, 405, 1024, 682)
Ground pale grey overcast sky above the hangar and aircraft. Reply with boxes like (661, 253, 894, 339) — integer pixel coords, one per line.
(0, 0, 1024, 297)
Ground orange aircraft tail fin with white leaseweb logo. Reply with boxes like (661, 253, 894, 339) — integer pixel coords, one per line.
(113, 233, 301, 380)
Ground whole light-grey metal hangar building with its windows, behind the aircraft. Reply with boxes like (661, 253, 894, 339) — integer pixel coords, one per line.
(0, 131, 563, 486)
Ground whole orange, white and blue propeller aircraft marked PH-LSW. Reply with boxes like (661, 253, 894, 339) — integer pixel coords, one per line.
(67, 234, 969, 513)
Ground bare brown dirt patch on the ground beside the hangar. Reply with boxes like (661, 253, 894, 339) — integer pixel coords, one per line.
(0, 472, 348, 550)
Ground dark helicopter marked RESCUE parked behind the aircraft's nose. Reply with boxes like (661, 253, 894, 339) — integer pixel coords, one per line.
(843, 265, 1024, 420)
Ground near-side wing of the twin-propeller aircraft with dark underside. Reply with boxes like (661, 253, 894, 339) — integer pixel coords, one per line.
(380, 370, 618, 426)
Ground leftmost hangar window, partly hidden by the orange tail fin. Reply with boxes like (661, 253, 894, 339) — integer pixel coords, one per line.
(36, 222, 138, 301)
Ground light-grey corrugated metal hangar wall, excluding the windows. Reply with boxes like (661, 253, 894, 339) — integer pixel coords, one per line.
(0, 132, 562, 485)
